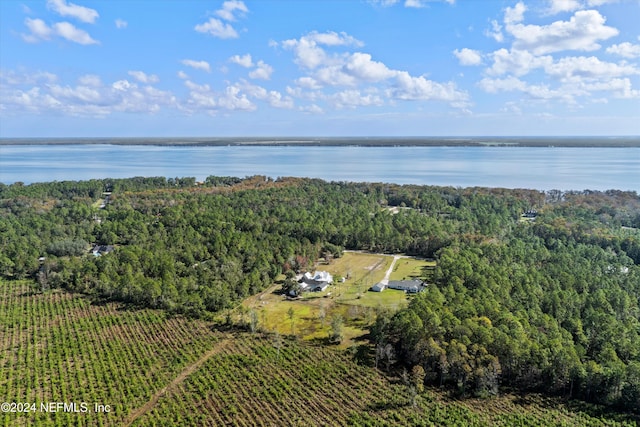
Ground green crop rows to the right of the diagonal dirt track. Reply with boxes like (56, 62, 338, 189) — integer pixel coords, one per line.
(134, 334, 636, 426)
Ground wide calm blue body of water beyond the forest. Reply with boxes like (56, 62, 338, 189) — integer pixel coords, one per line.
(0, 144, 640, 192)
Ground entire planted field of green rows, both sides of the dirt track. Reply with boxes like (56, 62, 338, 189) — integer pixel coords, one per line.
(0, 281, 636, 427)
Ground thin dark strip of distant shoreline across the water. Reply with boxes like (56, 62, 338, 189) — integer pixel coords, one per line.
(0, 136, 640, 148)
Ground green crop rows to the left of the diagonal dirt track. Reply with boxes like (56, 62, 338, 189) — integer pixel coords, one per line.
(0, 283, 221, 426)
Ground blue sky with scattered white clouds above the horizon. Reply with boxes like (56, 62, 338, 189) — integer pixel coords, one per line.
(0, 0, 640, 137)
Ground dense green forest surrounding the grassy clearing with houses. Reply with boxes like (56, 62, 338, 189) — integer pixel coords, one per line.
(0, 176, 640, 411)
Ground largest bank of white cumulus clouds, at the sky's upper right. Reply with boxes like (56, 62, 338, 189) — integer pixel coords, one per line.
(472, 0, 640, 107)
